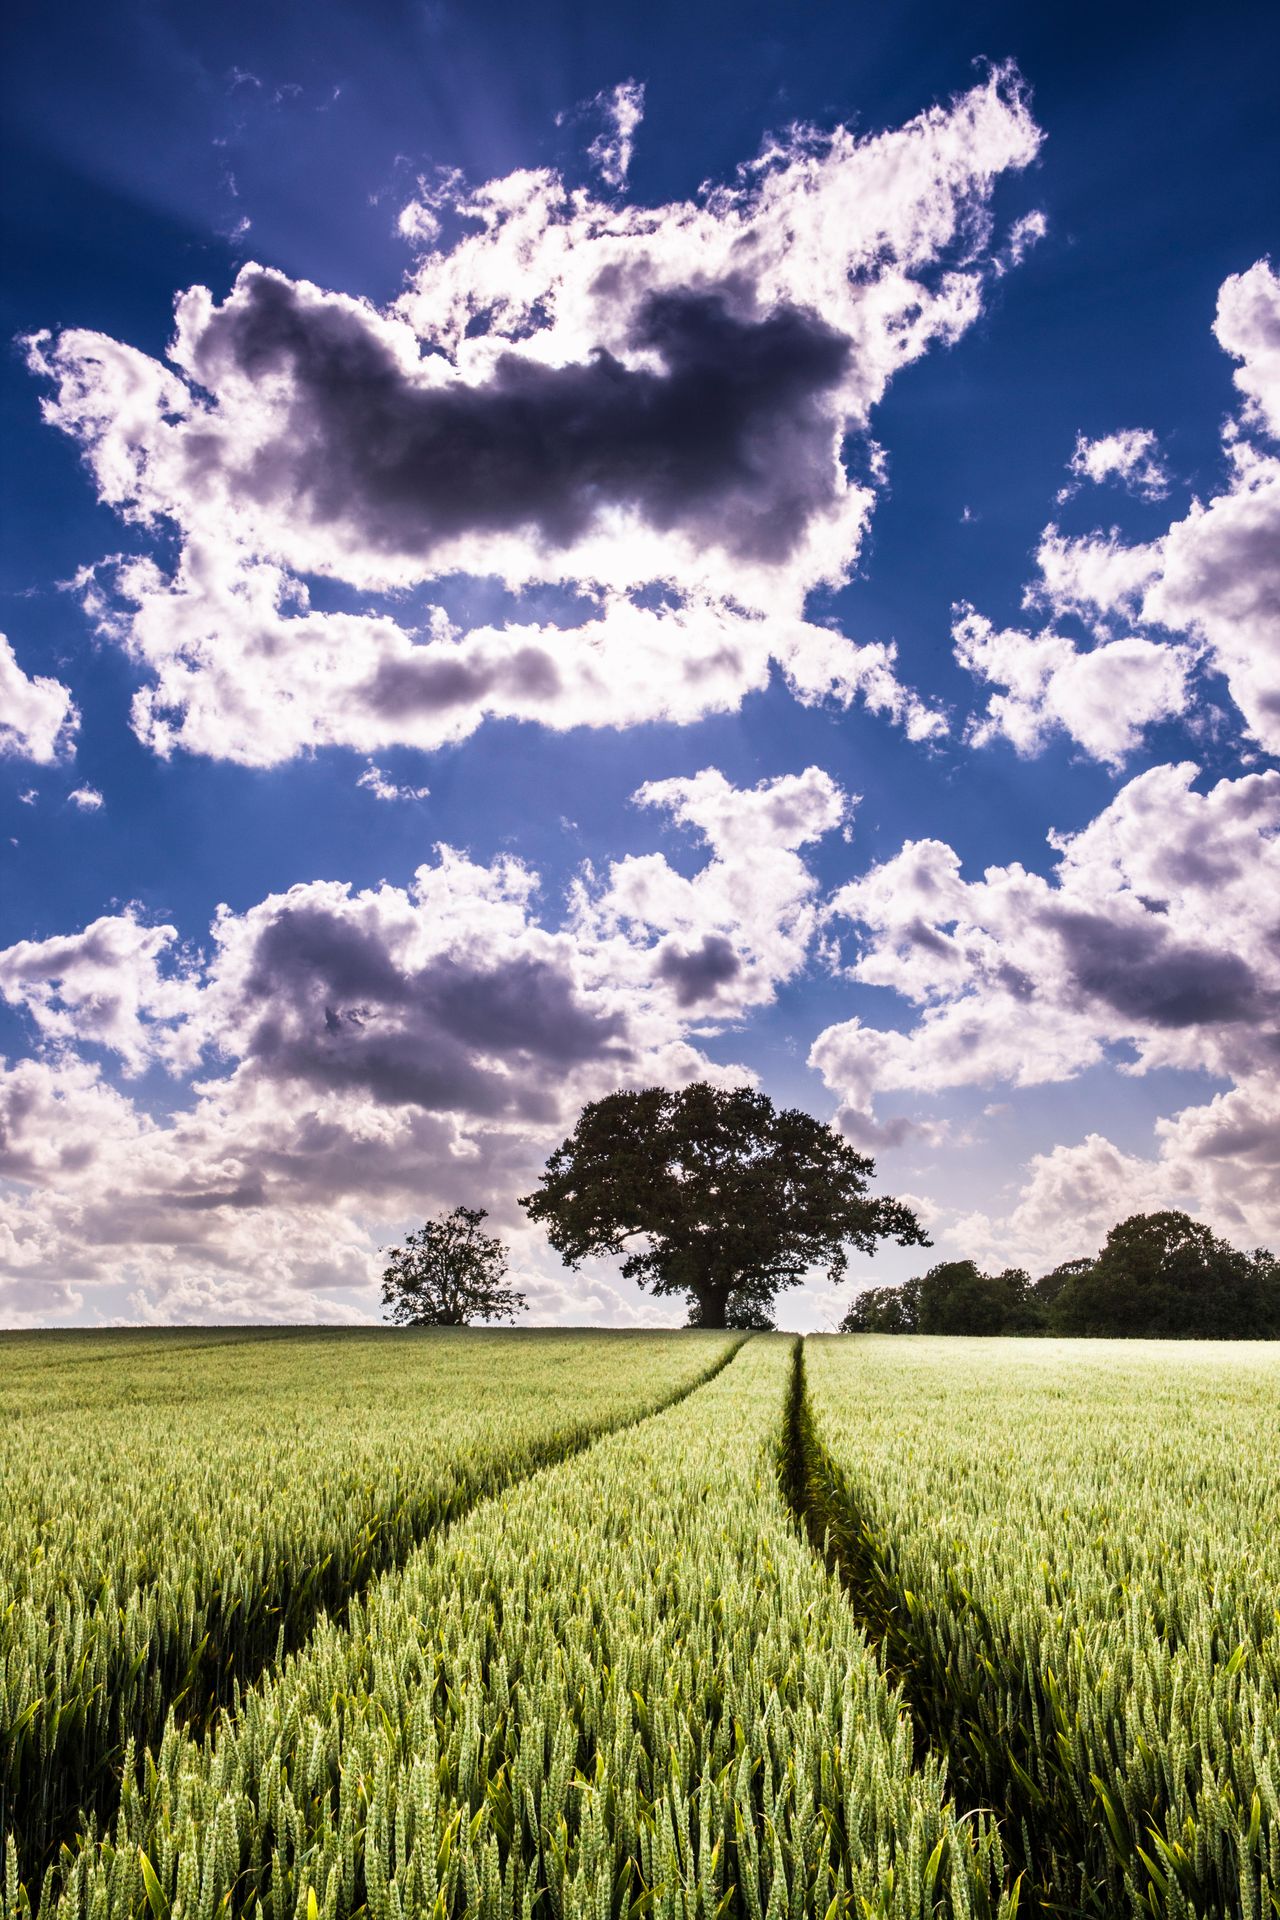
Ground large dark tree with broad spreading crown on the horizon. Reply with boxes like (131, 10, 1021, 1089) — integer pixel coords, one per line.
(520, 1081, 929, 1327)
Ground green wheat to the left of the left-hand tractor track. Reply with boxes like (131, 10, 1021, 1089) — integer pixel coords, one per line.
(0, 1331, 733, 1887)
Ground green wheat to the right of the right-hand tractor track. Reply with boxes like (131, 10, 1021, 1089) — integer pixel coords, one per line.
(806, 1338, 1280, 1920)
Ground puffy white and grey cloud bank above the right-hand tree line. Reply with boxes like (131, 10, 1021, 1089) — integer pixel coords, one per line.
(810, 764, 1280, 1125)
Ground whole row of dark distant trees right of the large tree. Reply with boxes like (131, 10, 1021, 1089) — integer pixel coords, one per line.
(841, 1213, 1280, 1340)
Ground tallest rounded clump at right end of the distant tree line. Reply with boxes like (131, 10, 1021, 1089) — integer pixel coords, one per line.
(1050, 1213, 1280, 1340)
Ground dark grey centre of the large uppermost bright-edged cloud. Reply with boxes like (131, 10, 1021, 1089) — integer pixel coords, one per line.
(186, 269, 850, 561)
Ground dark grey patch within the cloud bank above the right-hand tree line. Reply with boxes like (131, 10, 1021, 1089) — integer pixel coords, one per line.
(1044, 908, 1265, 1027)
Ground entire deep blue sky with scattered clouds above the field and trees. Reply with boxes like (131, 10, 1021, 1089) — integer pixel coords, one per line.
(0, 0, 1280, 1329)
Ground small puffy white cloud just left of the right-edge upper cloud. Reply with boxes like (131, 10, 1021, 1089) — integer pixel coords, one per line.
(952, 605, 1194, 766)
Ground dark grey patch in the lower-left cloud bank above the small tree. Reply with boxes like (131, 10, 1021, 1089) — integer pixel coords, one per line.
(238, 906, 628, 1117)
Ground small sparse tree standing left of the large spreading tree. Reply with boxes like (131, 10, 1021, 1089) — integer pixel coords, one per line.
(382, 1206, 526, 1327)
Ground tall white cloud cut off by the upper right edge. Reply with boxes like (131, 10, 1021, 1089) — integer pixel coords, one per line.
(1029, 261, 1280, 751)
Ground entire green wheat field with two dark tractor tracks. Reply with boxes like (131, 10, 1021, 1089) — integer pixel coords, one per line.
(0, 1332, 1280, 1920)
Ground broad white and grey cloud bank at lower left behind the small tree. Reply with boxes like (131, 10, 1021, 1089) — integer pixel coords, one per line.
(0, 768, 848, 1319)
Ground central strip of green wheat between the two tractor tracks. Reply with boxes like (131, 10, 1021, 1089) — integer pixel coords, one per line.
(45, 1334, 1013, 1920)
